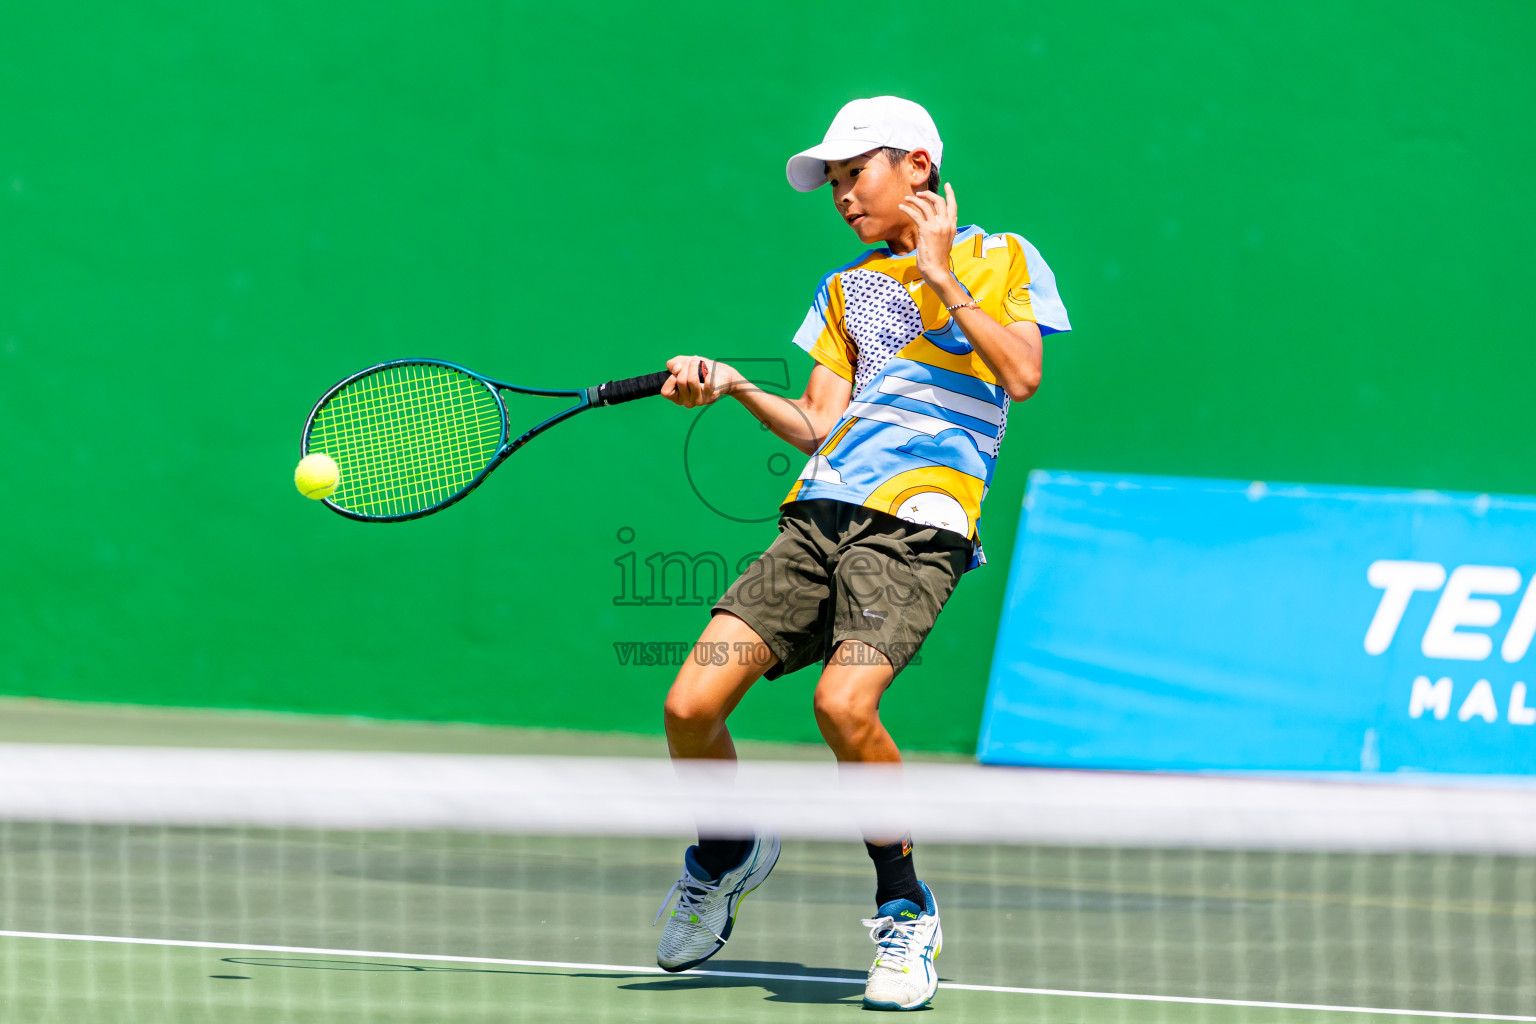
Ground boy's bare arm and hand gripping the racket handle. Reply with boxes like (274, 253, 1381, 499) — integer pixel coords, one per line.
(662, 356, 854, 454)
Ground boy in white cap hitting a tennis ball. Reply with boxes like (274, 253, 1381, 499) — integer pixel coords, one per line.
(656, 97, 1071, 1010)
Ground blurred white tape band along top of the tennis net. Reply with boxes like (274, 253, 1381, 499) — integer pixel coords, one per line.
(0, 743, 1536, 855)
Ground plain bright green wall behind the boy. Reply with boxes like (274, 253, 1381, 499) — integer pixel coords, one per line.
(0, 0, 1536, 749)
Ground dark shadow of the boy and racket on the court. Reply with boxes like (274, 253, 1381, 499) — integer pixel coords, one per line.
(220, 956, 865, 1006)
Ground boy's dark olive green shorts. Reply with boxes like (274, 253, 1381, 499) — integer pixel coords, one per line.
(714, 499, 971, 679)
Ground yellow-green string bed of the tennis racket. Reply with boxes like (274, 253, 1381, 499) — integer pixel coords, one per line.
(304, 364, 504, 517)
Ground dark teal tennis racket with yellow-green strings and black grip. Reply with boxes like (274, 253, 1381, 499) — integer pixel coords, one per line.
(300, 359, 703, 522)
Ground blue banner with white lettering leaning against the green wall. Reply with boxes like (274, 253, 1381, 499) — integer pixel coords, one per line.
(977, 471, 1536, 774)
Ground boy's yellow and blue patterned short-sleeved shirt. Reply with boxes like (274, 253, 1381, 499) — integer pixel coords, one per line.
(783, 226, 1072, 567)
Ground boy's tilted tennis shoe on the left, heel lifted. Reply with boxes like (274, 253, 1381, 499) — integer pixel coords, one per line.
(656, 834, 779, 972)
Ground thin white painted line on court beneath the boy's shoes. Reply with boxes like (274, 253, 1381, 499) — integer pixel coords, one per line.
(0, 930, 1536, 1024)
